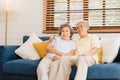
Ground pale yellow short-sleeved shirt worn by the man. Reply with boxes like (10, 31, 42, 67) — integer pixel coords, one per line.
(75, 34, 100, 62)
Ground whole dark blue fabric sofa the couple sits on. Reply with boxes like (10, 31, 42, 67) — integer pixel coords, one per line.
(0, 36, 120, 80)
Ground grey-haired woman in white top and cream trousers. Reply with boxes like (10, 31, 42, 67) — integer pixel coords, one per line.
(37, 24, 75, 80)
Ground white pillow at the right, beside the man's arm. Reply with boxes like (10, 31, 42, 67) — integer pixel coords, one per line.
(101, 38, 120, 63)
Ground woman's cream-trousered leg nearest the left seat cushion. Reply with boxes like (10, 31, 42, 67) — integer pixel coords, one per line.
(37, 58, 52, 80)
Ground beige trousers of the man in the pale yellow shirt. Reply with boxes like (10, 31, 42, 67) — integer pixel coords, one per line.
(55, 56, 96, 80)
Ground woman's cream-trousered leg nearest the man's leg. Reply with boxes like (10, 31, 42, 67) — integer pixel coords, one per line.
(49, 60, 59, 80)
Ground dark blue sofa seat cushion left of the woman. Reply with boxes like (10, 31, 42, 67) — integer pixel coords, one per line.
(3, 59, 40, 76)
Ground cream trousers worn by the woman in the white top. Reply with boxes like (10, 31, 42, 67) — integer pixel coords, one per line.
(37, 58, 59, 80)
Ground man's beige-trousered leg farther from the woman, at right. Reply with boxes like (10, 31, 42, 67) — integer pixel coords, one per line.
(75, 56, 96, 80)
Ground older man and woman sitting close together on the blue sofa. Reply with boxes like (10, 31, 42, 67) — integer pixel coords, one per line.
(37, 21, 100, 80)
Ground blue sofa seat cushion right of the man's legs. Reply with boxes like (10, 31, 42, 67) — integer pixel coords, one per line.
(87, 63, 120, 79)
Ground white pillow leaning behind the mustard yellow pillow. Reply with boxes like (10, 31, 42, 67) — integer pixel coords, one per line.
(15, 33, 42, 60)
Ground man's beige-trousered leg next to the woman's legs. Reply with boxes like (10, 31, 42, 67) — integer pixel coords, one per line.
(55, 56, 75, 80)
